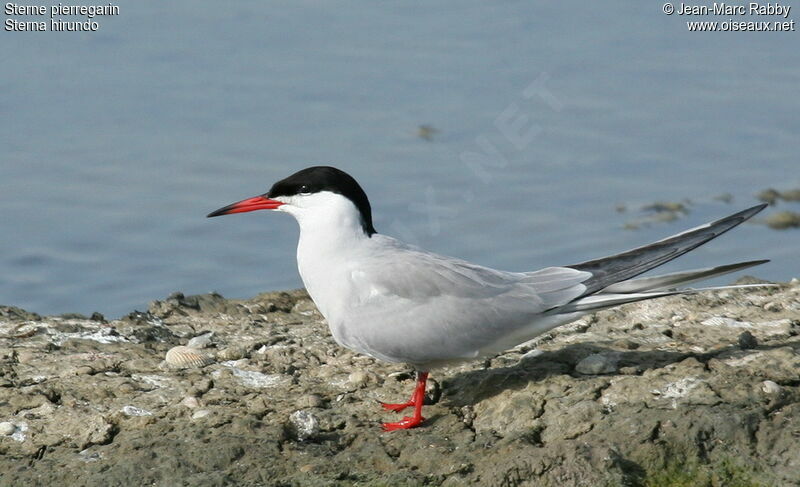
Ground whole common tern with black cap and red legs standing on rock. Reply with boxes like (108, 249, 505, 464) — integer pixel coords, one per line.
(208, 166, 768, 431)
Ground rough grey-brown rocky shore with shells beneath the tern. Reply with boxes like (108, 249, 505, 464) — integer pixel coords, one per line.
(0, 281, 800, 487)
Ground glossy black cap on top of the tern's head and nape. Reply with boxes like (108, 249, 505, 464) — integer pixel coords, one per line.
(266, 166, 377, 235)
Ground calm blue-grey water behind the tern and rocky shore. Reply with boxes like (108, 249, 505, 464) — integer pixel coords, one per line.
(0, 0, 800, 316)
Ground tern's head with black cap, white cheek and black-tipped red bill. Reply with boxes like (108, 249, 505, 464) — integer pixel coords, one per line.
(208, 166, 376, 236)
